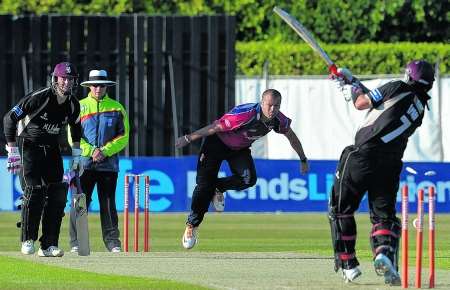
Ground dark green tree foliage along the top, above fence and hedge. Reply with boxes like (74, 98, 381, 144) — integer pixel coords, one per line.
(0, 0, 450, 43)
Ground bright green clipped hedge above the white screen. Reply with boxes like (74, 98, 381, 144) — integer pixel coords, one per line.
(236, 42, 450, 76)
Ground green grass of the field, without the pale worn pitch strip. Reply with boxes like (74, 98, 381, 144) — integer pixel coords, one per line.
(0, 212, 450, 289)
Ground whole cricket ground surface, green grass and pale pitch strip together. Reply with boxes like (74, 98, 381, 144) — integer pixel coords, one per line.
(0, 212, 450, 289)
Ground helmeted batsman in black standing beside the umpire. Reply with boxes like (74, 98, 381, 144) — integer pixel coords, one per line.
(3, 62, 81, 257)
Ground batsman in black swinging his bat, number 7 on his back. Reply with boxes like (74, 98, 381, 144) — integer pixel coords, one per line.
(329, 60, 434, 285)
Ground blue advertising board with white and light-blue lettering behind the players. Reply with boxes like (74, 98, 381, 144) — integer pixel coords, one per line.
(0, 156, 450, 213)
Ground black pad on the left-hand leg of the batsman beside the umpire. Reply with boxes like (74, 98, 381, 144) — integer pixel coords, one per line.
(21, 185, 46, 241)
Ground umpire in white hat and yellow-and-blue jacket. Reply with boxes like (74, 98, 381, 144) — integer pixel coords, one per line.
(70, 70, 130, 253)
